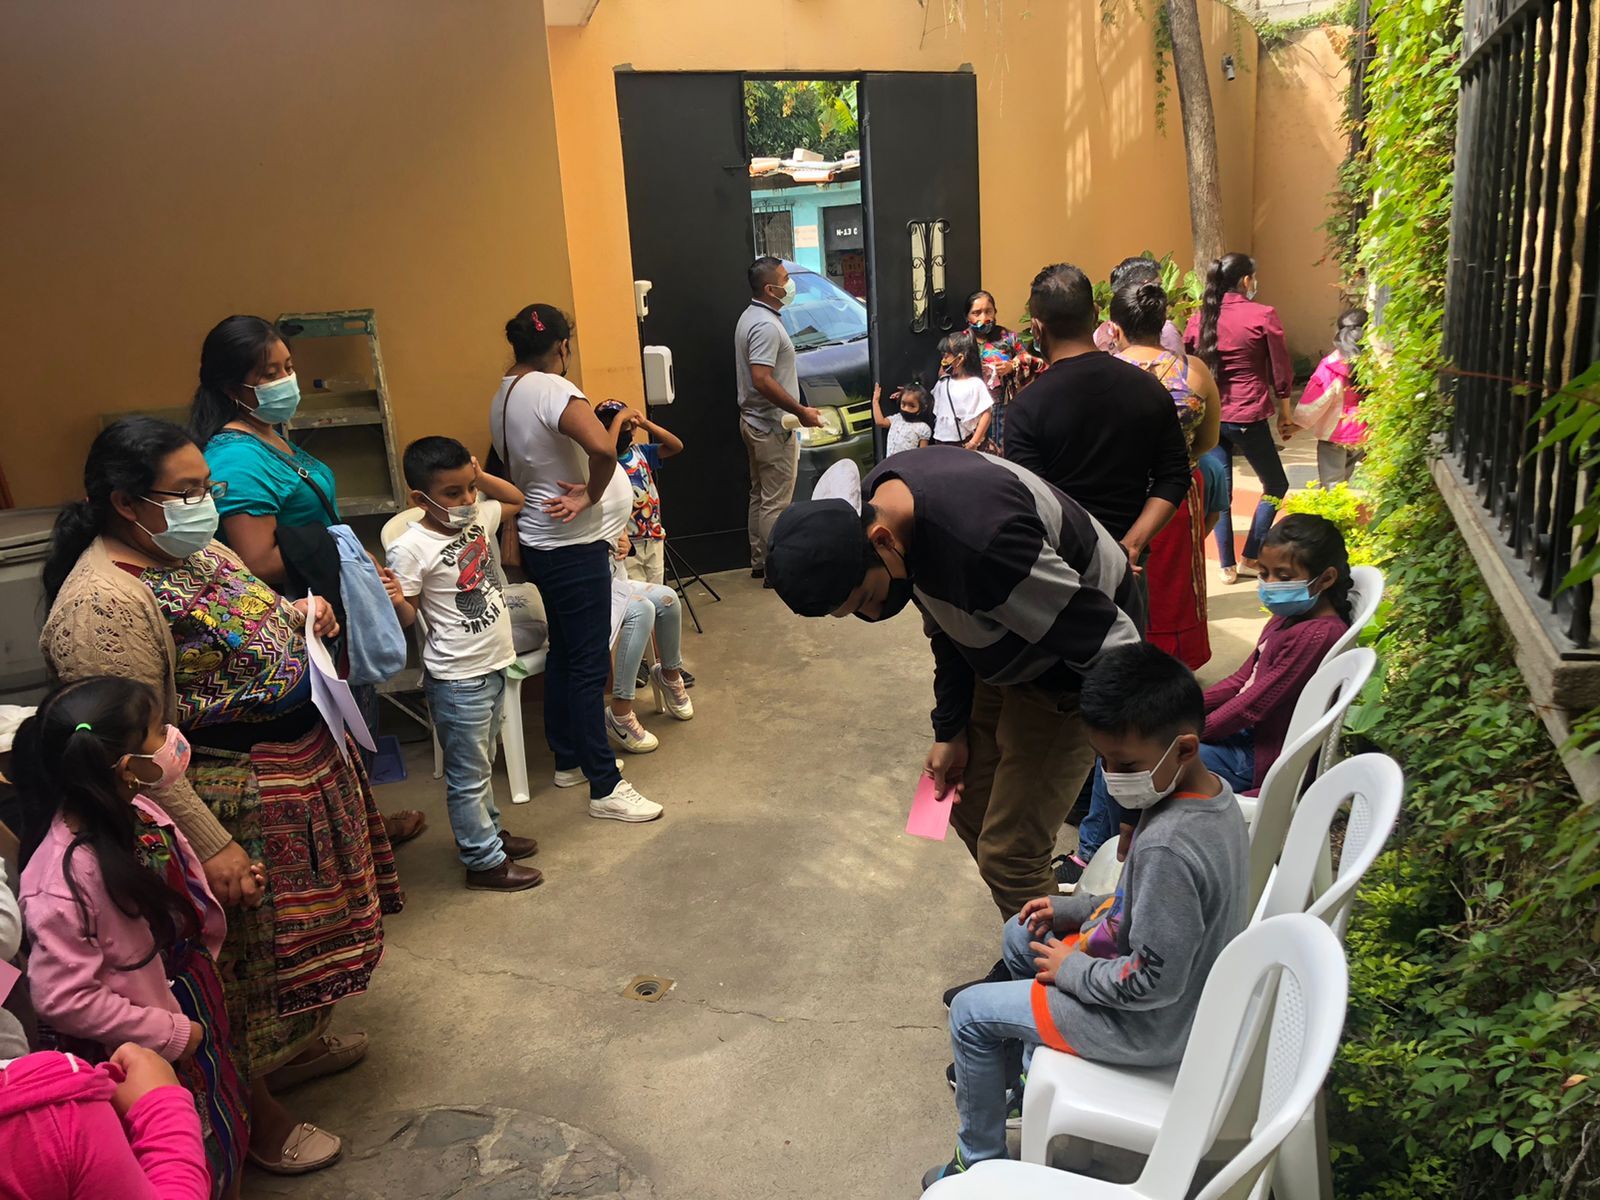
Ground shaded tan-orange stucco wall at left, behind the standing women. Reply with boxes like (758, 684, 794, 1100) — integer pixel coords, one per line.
(0, 0, 571, 506)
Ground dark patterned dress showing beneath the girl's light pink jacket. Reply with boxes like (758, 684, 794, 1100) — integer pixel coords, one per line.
(134, 813, 250, 1197)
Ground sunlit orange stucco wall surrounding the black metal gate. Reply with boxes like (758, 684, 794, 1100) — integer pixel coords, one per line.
(549, 0, 1259, 409)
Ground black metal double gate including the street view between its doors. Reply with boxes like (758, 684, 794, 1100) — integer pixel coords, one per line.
(616, 67, 981, 571)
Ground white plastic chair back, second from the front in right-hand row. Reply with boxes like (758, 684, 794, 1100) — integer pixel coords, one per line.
(1261, 754, 1405, 941)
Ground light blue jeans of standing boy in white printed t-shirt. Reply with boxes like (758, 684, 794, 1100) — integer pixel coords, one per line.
(422, 670, 506, 870)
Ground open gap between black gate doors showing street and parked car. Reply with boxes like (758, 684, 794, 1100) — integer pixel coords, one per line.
(744, 77, 877, 498)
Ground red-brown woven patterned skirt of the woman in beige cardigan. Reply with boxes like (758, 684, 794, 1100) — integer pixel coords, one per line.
(189, 725, 405, 1074)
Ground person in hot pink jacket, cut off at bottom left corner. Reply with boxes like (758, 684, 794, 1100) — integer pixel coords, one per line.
(0, 1042, 211, 1200)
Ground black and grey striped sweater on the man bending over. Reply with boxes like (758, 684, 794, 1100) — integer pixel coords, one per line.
(861, 446, 1139, 741)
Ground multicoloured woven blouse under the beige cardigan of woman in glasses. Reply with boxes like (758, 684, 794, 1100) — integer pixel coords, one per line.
(139, 549, 310, 731)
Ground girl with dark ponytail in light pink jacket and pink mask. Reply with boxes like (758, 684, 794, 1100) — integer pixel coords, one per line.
(14, 677, 250, 1197)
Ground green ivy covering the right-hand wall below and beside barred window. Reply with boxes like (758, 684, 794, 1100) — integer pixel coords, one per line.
(1312, 0, 1600, 1200)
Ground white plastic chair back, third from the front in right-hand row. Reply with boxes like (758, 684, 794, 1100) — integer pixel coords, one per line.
(1250, 646, 1378, 912)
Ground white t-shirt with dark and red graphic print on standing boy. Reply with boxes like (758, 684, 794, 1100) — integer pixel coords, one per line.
(389, 501, 517, 680)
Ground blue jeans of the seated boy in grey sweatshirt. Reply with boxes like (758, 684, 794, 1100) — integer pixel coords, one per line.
(950, 917, 1056, 1163)
